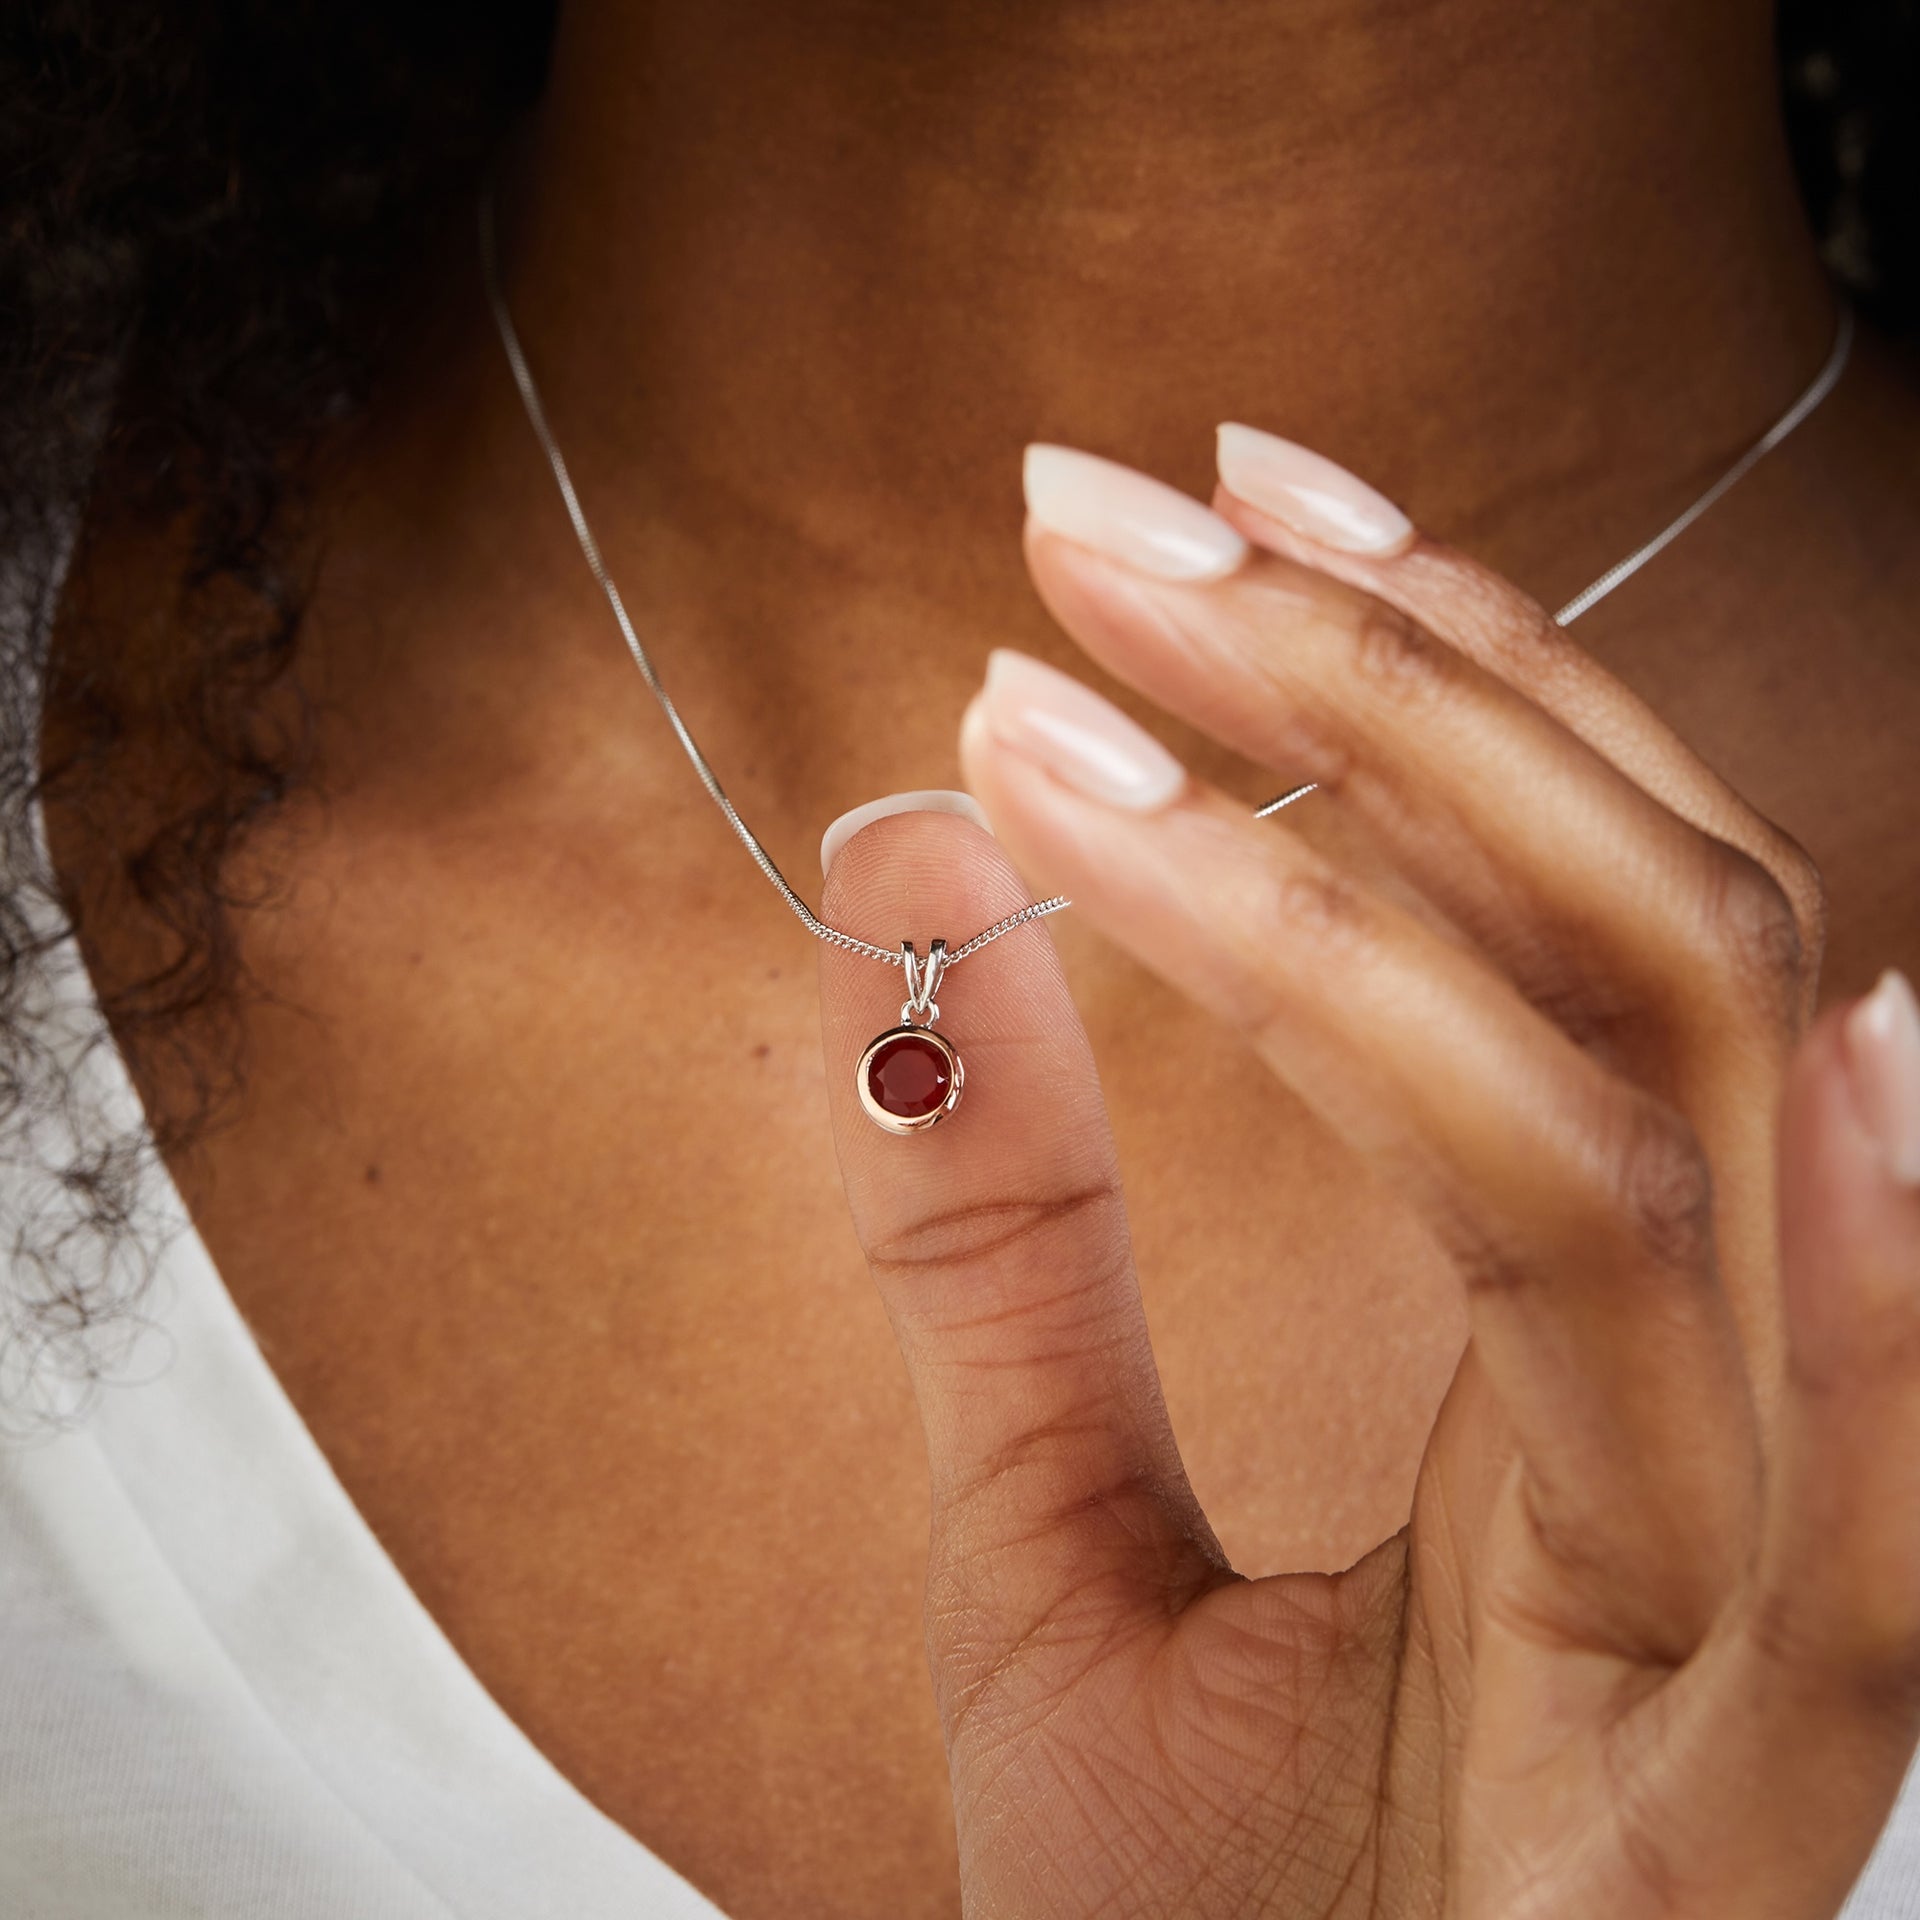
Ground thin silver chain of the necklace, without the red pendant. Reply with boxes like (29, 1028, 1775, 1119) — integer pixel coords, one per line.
(478, 190, 1853, 966)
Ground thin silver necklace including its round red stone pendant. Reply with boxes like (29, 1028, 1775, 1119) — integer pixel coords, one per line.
(480, 192, 1853, 1133)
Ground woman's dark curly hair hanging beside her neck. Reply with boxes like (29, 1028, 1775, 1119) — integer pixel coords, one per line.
(0, 0, 1920, 1405)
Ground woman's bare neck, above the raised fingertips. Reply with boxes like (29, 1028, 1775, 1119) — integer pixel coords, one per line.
(509, 0, 1832, 593)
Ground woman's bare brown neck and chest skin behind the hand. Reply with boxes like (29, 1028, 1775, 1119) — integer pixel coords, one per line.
(41, 0, 1920, 1920)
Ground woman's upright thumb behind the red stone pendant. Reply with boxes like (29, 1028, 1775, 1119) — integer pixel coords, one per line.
(820, 795, 1221, 1732)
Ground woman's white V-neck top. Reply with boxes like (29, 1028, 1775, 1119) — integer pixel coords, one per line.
(0, 875, 1920, 1920)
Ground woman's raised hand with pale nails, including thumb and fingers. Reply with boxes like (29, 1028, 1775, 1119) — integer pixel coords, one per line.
(824, 440, 1920, 1920)
